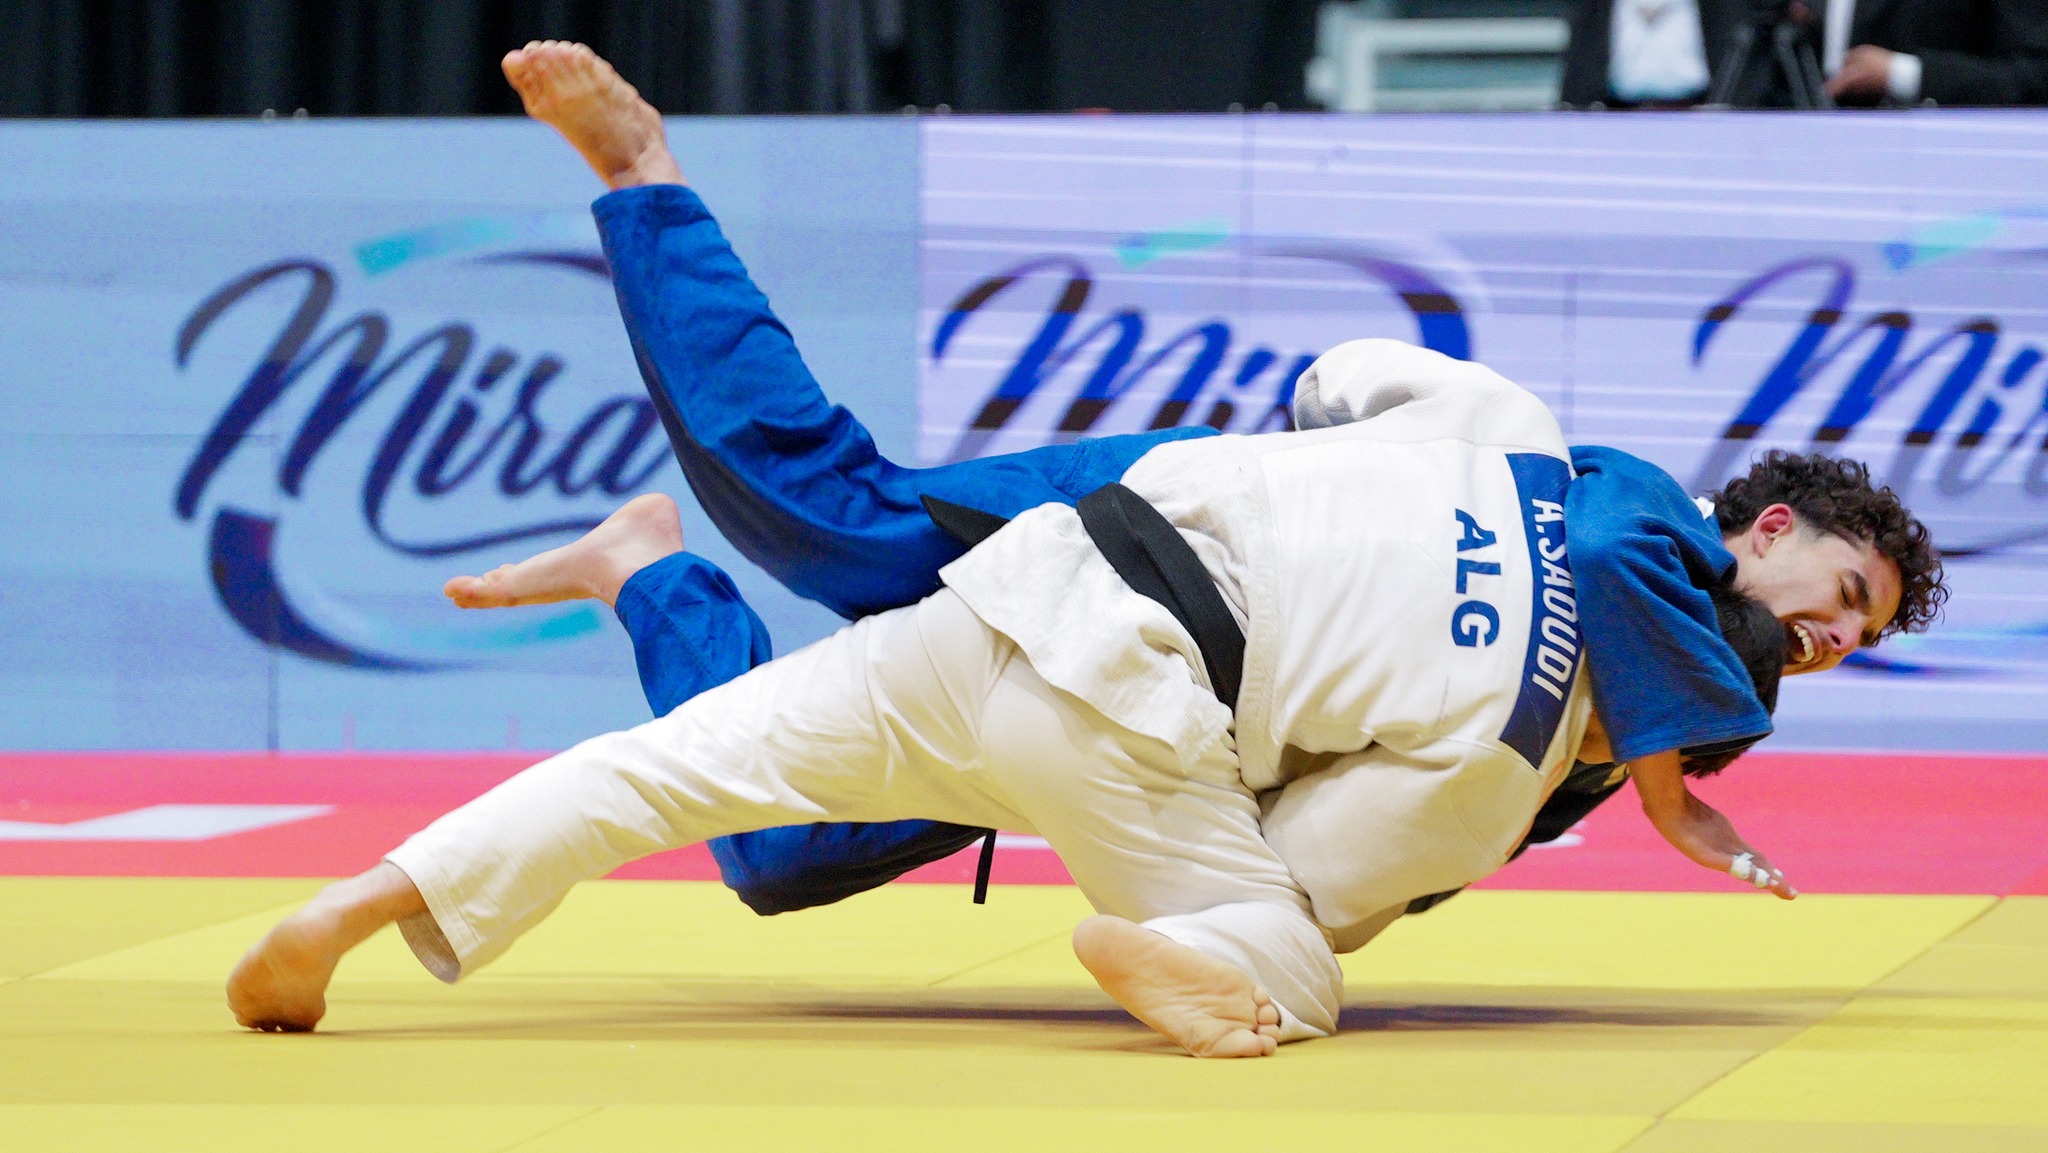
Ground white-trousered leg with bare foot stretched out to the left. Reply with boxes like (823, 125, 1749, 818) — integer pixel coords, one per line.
(229, 594, 1018, 1030)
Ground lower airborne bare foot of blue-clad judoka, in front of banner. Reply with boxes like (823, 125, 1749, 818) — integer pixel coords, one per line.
(440, 492, 682, 608)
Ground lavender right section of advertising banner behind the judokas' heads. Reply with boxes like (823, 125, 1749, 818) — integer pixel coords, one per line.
(918, 113, 2048, 750)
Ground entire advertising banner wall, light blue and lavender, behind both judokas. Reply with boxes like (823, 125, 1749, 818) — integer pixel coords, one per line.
(0, 113, 2048, 750)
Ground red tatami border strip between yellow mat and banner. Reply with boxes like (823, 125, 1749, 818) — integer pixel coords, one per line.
(0, 752, 2048, 895)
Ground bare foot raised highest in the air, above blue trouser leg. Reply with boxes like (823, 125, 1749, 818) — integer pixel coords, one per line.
(504, 41, 682, 188)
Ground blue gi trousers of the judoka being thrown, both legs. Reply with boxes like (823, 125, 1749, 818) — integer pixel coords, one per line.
(594, 184, 1212, 913)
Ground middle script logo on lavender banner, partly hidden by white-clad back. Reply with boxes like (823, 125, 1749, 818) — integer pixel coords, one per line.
(920, 225, 1473, 461)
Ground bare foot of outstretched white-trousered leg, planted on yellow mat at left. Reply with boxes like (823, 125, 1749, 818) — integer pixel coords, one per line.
(227, 864, 426, 1032)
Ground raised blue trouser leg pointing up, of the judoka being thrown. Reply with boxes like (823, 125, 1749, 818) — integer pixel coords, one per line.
(594, 184, 1212, 618)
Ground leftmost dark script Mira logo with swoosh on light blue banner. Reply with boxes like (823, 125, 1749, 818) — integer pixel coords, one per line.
(172, 213, 670, 672)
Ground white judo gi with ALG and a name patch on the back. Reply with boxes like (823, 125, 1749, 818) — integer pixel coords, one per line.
(387, 340, 1589, 1040)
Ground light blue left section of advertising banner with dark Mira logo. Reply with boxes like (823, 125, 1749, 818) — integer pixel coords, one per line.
(0, 121, 918, 750)
